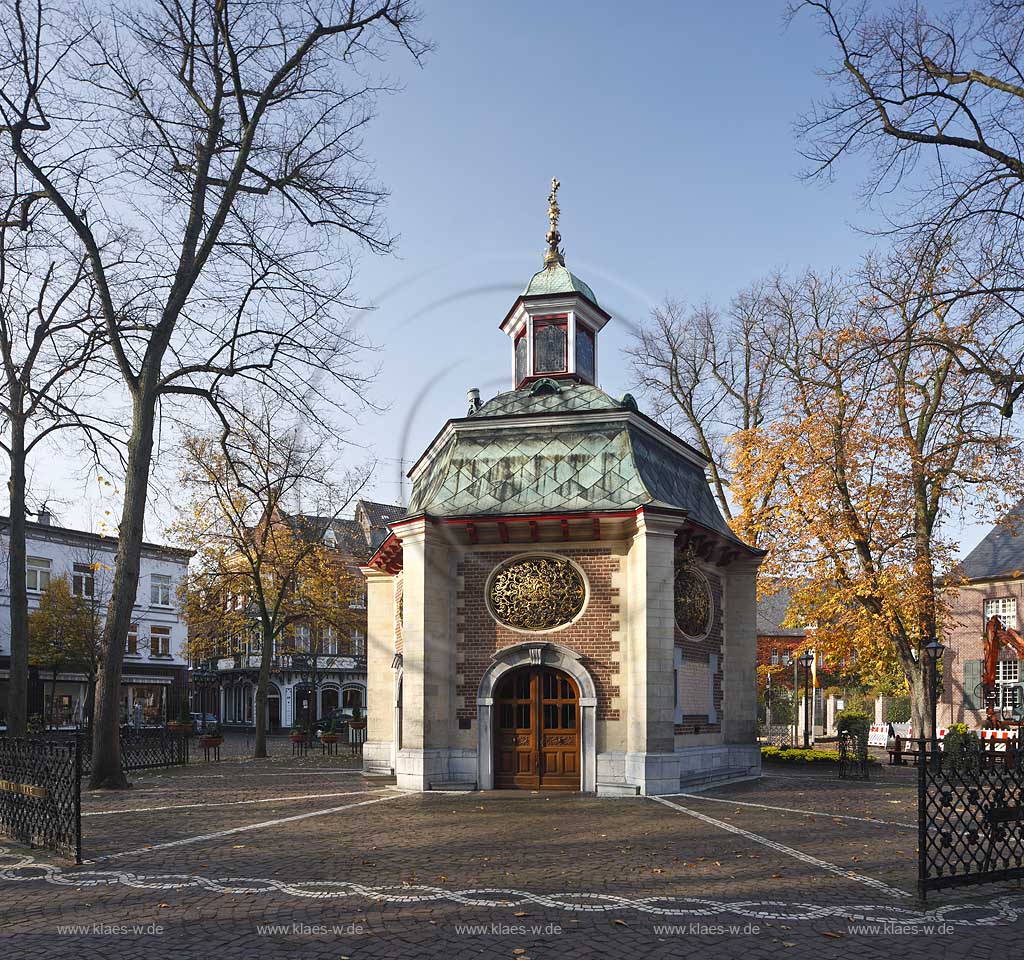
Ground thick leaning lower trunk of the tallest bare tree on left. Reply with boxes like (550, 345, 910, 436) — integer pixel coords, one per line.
(89, 387, 157, 790)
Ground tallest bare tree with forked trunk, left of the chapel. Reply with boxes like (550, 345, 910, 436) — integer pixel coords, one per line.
(0, 0, 425, 787)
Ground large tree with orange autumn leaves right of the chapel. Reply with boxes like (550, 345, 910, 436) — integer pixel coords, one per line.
(630, 238, 1024, 733)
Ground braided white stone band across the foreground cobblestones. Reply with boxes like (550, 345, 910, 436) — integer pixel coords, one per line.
(0, 847, 1024, 926)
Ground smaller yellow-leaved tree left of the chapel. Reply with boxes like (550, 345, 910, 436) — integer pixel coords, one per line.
(173, 403, 364, 757)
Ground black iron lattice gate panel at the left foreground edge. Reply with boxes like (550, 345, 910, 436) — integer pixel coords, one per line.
(0, 737, 82, 863)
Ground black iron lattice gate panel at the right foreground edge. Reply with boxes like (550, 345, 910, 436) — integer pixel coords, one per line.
(918, 739, 1024, 899)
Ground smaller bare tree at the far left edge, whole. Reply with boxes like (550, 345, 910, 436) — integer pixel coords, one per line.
(0, 162, 114, 735)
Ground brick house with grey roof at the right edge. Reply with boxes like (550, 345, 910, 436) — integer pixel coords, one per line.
(938, 501, 1024, 727)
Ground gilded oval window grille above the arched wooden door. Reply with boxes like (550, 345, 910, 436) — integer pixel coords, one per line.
(487, 557, 587, 631)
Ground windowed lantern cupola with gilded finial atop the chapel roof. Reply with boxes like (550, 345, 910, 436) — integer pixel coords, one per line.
(501, 179, 611, 388)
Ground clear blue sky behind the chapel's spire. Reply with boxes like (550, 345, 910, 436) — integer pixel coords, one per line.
(37, 0, 991, 543)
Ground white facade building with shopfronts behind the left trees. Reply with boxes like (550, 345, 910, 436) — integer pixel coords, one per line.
(0, 511, 190, 726)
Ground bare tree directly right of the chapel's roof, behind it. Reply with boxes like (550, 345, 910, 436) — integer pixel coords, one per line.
(627, 277, 782, 544)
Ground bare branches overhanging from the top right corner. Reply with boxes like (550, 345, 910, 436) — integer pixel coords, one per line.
(791, 0, 1024, 417)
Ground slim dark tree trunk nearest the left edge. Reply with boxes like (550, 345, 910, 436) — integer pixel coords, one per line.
(7, 411, 29, 737)
